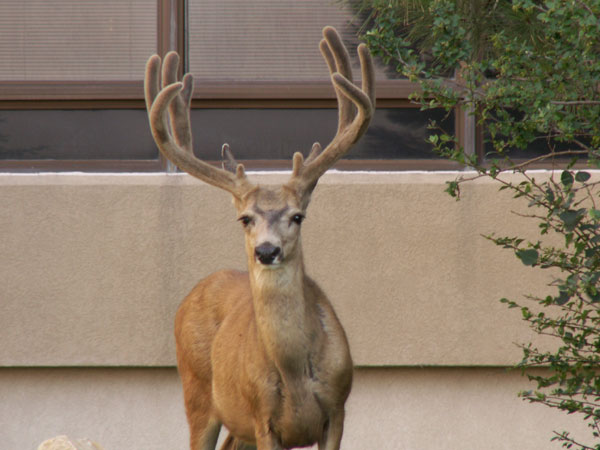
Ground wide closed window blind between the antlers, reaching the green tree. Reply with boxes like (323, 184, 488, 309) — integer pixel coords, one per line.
(188, 0, 394, 82)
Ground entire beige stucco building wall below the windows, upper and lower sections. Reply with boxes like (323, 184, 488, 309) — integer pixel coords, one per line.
(0, 172, 585, 450)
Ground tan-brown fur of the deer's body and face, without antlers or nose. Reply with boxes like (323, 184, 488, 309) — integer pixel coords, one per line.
(175, 188, 352, 450)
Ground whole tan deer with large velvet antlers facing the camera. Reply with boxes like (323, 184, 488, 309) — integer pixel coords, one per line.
(144, 27, 375, 450)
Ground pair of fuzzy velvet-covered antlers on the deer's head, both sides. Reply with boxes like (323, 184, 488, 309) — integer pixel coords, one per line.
(144, 27, 375, 198)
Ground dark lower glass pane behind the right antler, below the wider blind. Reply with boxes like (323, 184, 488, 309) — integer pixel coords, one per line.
(192, 108, 454, 160)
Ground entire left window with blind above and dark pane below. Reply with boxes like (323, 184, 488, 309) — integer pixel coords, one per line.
(0, 0, 172, 170)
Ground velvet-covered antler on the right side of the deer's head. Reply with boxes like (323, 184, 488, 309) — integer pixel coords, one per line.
(290, 27, 375, 194)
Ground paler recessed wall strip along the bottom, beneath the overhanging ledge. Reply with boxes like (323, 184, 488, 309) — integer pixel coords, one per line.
(0, 368, 589, 450)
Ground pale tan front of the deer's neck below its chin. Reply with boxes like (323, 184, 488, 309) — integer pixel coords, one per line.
(250, 251, 315, 377)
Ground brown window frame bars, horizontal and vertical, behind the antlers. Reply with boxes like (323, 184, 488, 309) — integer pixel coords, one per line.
(0, 0, 467, 172)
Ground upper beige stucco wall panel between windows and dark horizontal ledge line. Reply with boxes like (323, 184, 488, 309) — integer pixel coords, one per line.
(0, 173, 564, 366)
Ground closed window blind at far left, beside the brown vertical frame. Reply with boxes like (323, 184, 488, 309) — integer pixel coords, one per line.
(0, 0, 158, 81)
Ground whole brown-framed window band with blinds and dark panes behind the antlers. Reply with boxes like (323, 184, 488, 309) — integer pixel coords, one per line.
(0, 0, 457, 171)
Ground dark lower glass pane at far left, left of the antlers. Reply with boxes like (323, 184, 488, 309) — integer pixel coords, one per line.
(0, 109, 158, 160)
